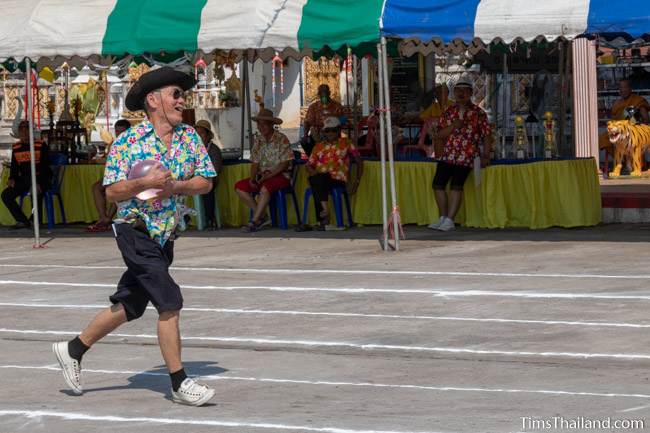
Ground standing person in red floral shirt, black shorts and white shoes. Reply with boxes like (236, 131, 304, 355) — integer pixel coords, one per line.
(429, 77, 492, 231)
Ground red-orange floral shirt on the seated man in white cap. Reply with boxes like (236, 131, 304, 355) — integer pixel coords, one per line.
(309, 137, 359, 182)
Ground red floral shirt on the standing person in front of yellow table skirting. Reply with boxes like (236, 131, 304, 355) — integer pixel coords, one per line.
(439, 104, 491, 167)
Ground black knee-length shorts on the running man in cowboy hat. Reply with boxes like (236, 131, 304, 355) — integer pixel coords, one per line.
(109, 224, 183, 320)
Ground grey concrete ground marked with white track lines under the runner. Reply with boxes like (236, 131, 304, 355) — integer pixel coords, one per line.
(0, 225, 650, 433)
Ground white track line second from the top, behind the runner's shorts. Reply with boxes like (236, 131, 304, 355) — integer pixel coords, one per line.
(0, 280, 650, 301)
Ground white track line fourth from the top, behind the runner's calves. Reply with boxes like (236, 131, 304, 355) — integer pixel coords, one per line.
(0, 328, 650, 361)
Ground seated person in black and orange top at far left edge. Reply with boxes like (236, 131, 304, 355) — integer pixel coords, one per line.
(2, 120, 50, 229)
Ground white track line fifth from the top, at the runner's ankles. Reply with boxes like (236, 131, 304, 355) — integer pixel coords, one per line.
(0, 365, 650, 399)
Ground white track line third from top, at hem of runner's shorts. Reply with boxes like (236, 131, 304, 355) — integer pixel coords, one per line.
(0, 302, 650, 329)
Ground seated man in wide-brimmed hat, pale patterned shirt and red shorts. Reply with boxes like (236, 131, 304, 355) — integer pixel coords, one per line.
(235, 108, 293, 232)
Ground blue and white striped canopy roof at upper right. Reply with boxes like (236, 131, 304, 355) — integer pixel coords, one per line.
(381, 0, 650, 43)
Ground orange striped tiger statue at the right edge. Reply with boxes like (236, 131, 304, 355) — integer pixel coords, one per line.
(607, 120, 650, 177)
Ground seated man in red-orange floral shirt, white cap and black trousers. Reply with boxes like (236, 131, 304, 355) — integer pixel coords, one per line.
(307, 117, 363, 230)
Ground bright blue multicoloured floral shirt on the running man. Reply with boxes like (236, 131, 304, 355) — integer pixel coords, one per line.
(103, 119, 216, 245)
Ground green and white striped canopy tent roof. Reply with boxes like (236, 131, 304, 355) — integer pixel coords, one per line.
(0, 0, 383, 69)
